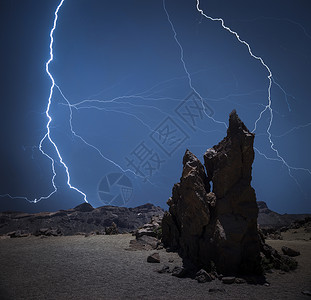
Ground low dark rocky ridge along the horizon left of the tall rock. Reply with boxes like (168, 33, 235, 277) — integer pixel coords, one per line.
(0, 203, 164, 236)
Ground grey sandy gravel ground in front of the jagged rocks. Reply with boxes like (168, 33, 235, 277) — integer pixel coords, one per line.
(0, 234, 311, 300)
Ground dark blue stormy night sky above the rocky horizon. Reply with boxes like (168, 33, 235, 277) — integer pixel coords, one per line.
(0, 0, 311, 213)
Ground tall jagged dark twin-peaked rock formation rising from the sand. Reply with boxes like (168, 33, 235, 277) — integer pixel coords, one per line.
(162, 111, 261, 274)
